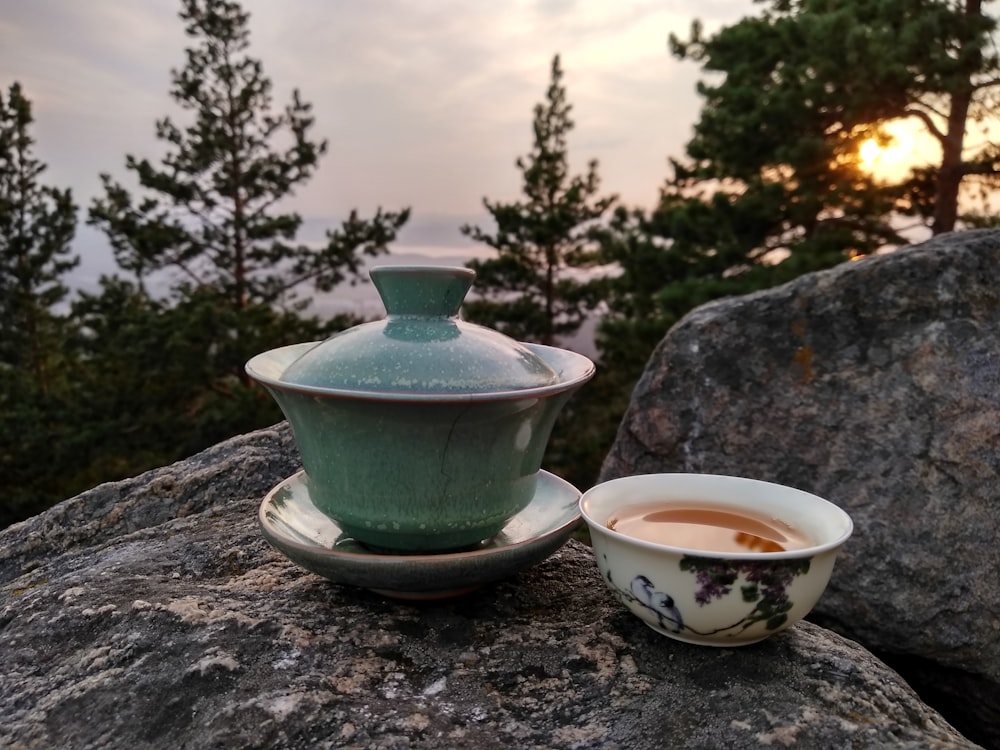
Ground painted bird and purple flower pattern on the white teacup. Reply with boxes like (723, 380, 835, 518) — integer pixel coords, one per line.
(605, 555, 812, 636)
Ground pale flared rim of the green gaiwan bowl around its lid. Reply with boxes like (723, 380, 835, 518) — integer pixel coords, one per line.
(246, 341, 595, 403)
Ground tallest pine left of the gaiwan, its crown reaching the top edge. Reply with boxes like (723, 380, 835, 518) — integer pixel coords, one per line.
(89, 0, 409, 310)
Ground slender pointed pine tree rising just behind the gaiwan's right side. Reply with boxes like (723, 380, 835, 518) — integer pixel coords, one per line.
(461, 55, 616, 344)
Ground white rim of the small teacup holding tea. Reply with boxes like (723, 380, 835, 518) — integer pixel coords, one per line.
(580, 472, 854, 562)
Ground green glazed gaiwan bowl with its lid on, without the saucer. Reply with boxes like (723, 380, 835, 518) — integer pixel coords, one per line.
(246, 266, 594, 553)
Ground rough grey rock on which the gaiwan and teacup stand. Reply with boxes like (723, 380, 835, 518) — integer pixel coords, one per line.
(0, 426, 975, 750)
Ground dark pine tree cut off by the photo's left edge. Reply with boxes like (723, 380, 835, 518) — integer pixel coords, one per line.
(0, 83, 79, 527)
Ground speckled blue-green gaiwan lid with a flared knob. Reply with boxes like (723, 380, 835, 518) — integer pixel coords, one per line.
(280, 266, 559, 394)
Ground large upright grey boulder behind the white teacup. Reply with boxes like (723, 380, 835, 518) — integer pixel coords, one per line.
(602, 231, 1000, 747)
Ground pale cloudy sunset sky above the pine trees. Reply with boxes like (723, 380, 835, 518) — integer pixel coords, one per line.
(0, 0, 759, 288)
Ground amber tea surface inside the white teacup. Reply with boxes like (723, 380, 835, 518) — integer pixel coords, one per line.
(607, 503, 814, 552)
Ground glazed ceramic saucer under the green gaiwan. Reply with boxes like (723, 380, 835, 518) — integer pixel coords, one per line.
(257, 471, 580, 599)
